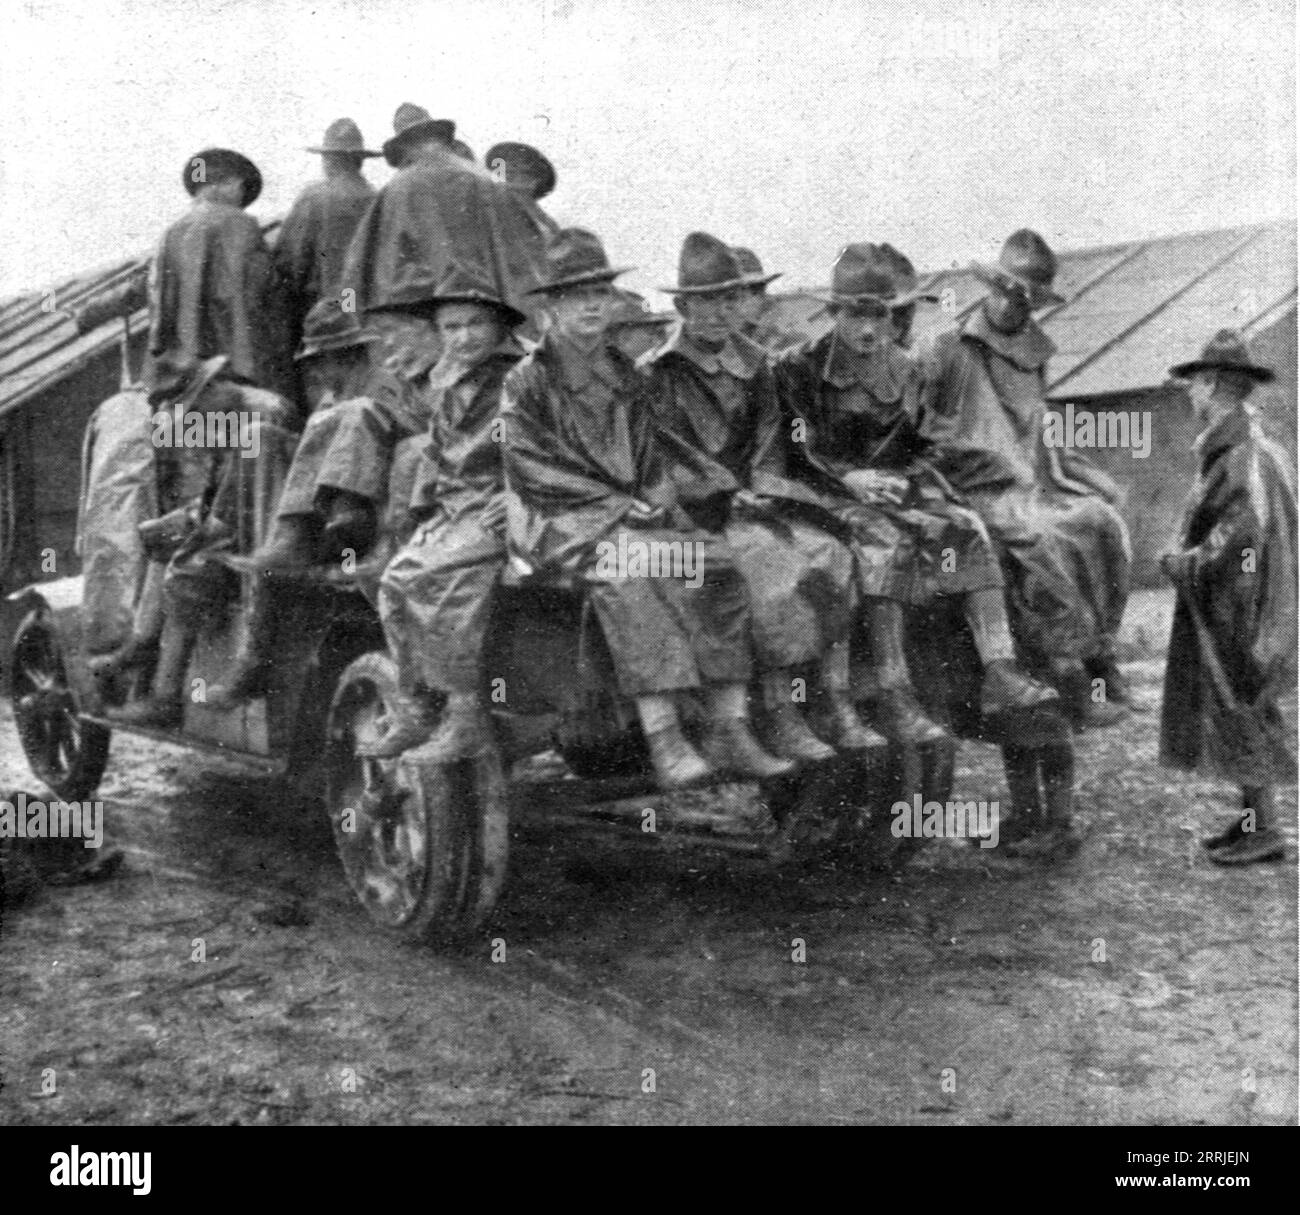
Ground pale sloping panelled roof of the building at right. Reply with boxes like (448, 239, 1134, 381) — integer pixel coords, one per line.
(781, 221, 1296, 400)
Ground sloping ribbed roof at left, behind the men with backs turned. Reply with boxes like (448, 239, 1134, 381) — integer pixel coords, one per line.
(0, 218, 280, 415)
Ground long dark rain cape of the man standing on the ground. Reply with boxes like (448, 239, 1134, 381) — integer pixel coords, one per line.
(1160, 409, 1296, 785)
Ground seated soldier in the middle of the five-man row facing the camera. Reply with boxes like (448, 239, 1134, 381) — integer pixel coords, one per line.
(645, 233, 909, 763)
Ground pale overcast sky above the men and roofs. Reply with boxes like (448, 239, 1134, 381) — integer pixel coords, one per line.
(0, 0, 1296, 301)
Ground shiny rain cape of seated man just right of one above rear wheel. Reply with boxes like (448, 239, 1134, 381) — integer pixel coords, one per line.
(502, 338, 751, 697)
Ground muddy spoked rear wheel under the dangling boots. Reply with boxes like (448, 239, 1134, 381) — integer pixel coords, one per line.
(325, 651, 510, 942)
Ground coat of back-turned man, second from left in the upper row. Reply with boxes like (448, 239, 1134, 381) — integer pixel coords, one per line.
(274, 173, 374, 340)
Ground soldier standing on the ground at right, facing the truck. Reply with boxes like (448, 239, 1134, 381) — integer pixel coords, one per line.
(1160, 330, 1296, 865)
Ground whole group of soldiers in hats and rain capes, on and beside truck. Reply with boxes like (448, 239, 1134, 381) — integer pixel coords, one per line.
(86, 104, 1295, 863)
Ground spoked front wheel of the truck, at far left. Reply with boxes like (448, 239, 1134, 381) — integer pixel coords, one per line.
(10, 612, 111, 802)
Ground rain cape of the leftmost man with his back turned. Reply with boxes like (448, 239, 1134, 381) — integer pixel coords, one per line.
(150, 199, 294, 395)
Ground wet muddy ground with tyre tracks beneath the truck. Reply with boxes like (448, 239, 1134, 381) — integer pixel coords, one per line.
(0, 595, 1296, 1124)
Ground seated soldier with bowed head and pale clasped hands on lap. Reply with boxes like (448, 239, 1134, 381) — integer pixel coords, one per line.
(776, 244, 1056, 717)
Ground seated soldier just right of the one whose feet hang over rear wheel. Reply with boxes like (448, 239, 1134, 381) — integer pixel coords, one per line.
(502, 229, 793, 789)
